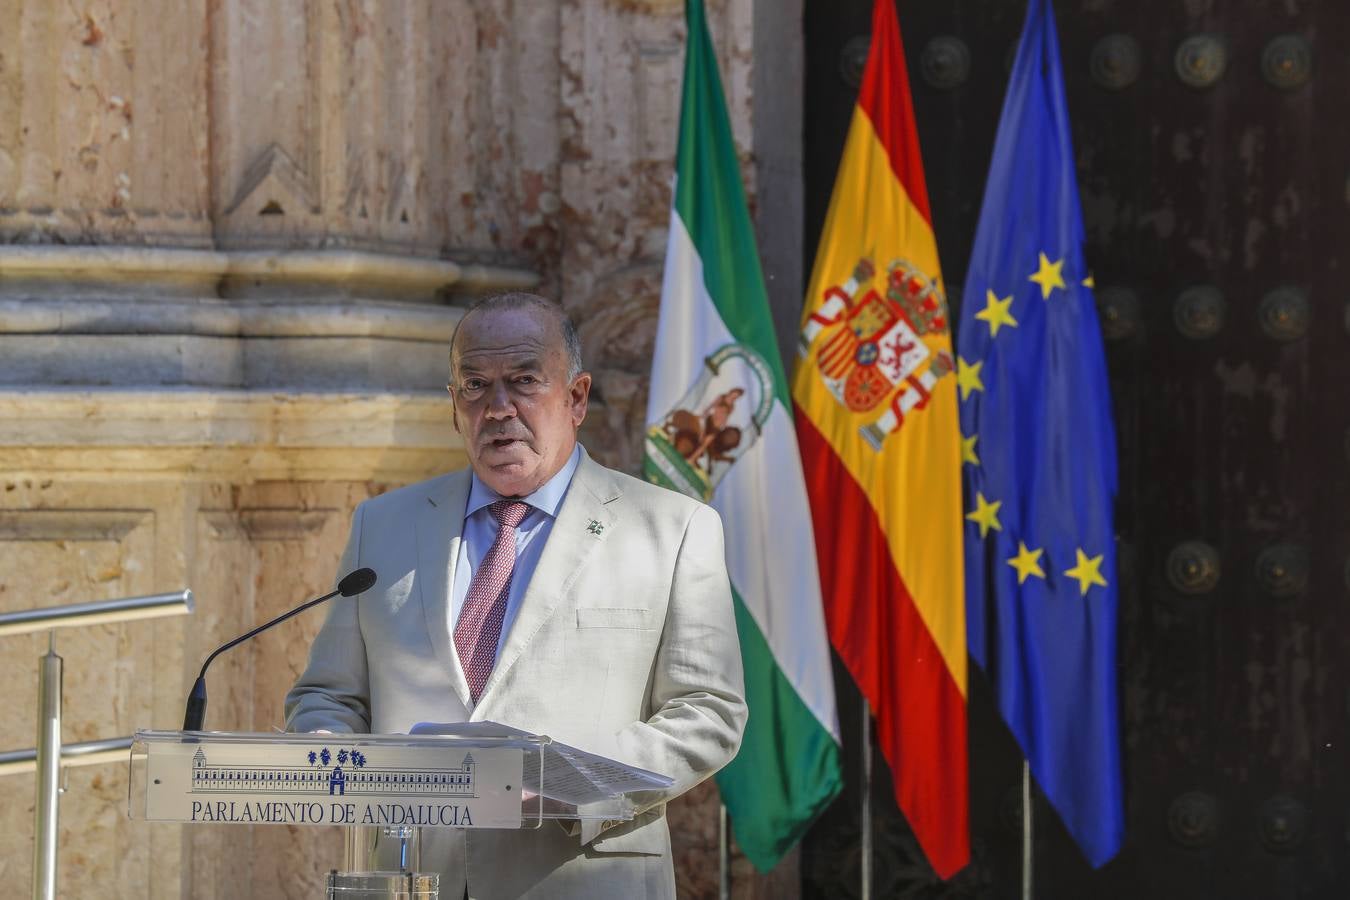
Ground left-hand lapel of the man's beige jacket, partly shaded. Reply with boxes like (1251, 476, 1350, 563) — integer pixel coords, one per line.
(413, 470, 470, 708)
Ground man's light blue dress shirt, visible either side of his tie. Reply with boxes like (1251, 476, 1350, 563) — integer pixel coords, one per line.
(450, 444, 582, 658)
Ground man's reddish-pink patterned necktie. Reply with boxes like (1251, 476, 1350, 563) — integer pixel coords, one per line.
(455, 501, 529, 703)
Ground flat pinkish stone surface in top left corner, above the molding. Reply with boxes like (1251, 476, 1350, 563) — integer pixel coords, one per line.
(0, 0, 211, 247)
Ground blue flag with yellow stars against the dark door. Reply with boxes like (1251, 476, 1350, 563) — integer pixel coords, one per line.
(957, 0, 1125, 866)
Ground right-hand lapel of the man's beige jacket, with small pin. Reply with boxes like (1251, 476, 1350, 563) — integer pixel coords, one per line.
(478, 449, 622, 708)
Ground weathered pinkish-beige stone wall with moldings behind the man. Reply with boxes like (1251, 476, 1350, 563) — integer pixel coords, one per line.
(0, 0, 801, 897)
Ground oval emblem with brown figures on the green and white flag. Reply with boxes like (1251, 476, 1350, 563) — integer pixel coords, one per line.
(644, 344, 774, 503)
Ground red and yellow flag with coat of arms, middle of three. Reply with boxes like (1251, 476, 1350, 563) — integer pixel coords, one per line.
(792, 0, 971, 877)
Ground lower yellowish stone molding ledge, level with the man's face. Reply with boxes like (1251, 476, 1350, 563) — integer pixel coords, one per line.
(0, 389, 464, 484)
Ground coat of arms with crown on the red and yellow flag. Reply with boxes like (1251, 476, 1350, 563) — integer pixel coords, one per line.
(799, 258, 956, 451)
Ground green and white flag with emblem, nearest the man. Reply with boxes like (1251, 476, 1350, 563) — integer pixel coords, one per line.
(643, 0, 842, 872)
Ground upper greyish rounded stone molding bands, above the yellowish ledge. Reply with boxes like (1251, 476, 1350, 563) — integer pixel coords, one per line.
(0, 246, 539, 394)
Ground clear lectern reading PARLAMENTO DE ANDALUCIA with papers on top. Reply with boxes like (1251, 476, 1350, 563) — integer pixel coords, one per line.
(128, 722, 671, 900)
